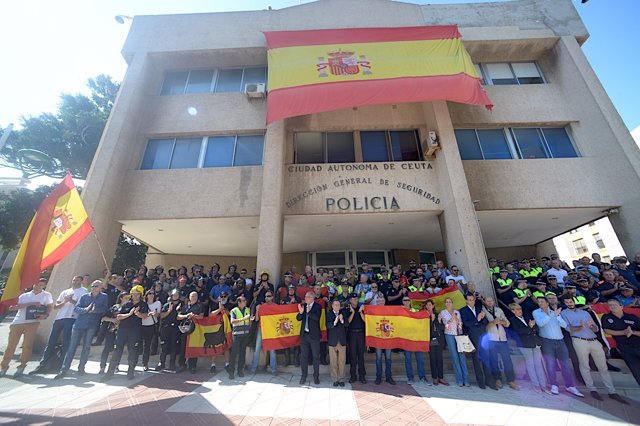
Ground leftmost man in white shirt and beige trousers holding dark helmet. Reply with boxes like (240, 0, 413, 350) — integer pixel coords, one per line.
(0, 278, 53, 377)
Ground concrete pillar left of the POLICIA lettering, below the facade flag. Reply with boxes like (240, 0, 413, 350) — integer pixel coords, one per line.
(256, 120, 286, 285)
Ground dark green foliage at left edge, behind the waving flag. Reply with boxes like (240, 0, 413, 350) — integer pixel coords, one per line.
(0, 185, 55, 250)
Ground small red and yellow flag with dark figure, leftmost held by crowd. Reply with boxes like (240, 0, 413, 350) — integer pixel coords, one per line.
(185, 313, 232, 358)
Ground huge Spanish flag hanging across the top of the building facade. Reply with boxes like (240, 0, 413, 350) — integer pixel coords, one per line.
(264, 25, 493, 124)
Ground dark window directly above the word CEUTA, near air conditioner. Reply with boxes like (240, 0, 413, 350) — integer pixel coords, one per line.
(360, 130, 422, 162)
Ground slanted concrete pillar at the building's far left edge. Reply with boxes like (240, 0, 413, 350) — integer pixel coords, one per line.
(36, 55, 148, 349)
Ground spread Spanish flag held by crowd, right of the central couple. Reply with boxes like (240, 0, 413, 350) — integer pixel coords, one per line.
(364, 305, 431, 352)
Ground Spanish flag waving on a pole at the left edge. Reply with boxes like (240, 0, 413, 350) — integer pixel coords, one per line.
(0, 175, 93, 311)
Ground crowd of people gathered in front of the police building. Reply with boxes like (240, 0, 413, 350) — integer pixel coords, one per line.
(0, 253, 640, 404)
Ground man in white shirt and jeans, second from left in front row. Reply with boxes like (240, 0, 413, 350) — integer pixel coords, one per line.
(29, 275, 88, 374)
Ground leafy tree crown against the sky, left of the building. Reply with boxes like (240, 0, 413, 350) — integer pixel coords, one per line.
(0, 74, 120, 179)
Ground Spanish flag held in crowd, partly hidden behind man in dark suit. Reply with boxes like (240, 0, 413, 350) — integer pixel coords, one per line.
(260, 299, 327, 351)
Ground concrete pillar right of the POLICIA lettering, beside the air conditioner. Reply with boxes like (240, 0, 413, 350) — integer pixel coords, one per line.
(424, 101, 493, 295)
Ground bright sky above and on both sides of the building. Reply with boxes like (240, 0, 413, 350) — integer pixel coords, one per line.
(0, 0, 640, 166)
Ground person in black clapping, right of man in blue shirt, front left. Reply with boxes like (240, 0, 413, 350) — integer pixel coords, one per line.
(100, 284, 149, 382)
